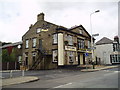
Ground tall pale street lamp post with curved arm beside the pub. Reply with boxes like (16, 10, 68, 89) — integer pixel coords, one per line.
(90, 10, 100, 69)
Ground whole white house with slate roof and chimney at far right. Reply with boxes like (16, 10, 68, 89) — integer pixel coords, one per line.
(95, 36, 120, 64)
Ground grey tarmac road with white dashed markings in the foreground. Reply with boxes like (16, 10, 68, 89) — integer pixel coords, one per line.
(3, 68, 120, 89)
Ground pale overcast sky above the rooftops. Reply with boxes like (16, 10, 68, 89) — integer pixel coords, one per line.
(0, 0, 118, 42)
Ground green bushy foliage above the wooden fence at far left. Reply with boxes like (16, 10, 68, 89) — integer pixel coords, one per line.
(2, 48, 16, 62)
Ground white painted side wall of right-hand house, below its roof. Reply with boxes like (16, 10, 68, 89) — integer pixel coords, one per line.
(95, 44, 113, 64)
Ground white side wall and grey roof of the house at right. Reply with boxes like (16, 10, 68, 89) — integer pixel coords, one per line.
(95, 37, 113, 64)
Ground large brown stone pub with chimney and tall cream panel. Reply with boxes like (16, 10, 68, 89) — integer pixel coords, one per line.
(22, 13, 91, 69)
